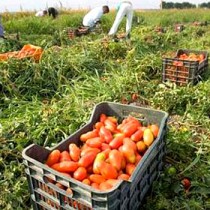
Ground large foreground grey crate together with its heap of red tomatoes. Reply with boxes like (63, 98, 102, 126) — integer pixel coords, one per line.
(22, 102, 168, 210)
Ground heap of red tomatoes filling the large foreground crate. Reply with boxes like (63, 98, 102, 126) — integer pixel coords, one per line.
(45, 114, 159, 191)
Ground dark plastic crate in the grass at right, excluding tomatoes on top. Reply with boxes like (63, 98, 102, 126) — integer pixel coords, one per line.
(162, 49, 208, 86)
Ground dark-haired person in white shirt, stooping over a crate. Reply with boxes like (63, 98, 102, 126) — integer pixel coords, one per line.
(83, 5, 109, 28)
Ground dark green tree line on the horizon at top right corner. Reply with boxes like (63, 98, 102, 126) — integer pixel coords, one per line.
(162, 1, 210, 9)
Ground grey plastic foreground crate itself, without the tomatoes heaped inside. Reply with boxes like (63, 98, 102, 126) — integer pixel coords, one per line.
(22, 102, 168, 210)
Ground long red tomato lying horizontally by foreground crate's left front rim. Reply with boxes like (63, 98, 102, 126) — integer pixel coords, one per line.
(51, 161, 78, 173)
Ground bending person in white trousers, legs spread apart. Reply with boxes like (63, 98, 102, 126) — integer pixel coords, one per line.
(108, 1, 133, 38)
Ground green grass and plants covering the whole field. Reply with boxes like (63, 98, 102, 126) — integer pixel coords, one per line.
(0, 10, 210, 210)
